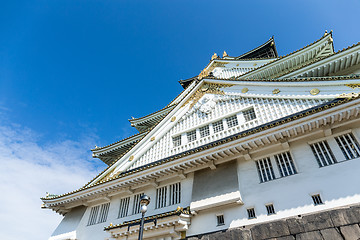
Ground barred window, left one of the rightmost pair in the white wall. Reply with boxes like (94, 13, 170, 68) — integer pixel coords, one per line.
(310, 141, 336, 167)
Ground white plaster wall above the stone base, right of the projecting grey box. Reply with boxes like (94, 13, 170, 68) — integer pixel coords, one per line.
(187, 128, 360, 236)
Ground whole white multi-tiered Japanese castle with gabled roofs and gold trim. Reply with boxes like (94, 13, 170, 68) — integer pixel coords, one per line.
(42, 32, 360, 240)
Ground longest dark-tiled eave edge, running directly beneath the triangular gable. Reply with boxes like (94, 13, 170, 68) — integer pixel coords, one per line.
(41, 94, 360, 204)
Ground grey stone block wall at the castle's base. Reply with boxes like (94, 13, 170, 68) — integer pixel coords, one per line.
(186, 205, 360, 240)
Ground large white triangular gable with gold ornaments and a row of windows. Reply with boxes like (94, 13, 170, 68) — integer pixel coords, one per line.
(91, 78, 360, 184)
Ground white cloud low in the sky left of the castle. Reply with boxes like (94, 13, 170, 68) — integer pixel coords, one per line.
(0, 121, 104, 240)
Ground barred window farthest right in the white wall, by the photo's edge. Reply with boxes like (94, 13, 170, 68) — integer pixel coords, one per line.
(335, 133, 360, 160)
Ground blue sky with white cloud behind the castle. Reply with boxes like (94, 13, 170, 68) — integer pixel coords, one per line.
(0, 0, 360, 240)
